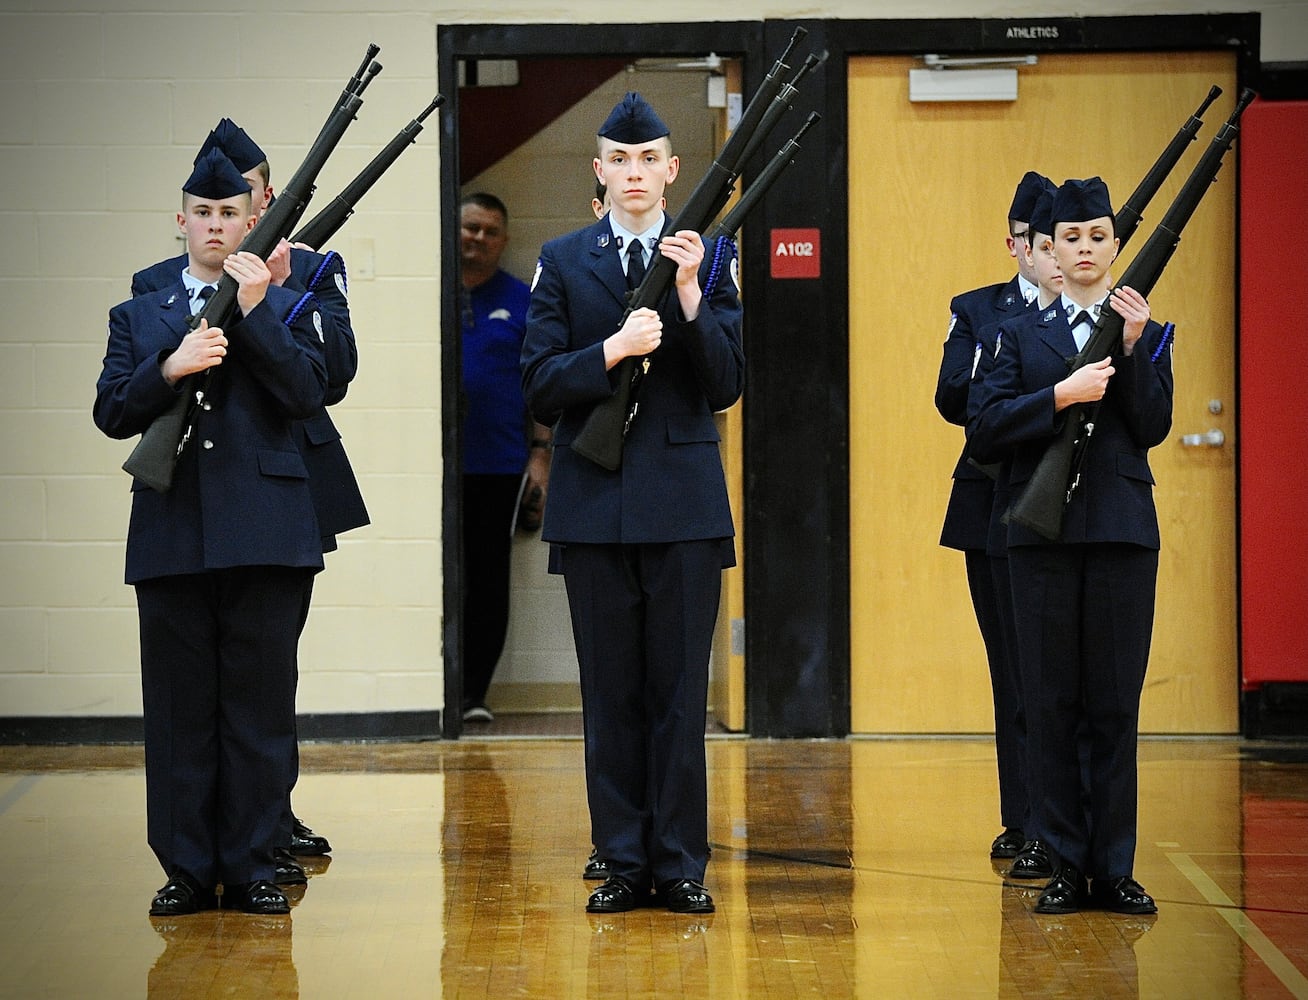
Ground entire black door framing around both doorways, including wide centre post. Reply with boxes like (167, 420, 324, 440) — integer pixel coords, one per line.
(437, 12, 1261, 739)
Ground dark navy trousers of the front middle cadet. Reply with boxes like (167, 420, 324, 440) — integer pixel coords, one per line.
(562, 540, 722, 886)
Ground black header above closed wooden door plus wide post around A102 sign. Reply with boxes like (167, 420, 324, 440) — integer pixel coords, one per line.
(742, 13, 1260, 737)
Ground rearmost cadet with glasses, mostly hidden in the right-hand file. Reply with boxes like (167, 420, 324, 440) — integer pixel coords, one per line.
(935, 170, 1053, 857)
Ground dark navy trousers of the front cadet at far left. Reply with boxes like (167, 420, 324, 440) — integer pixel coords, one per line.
(136, 566, 313, 885)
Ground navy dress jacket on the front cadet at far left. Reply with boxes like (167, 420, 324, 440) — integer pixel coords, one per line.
(94, 278, 327, 583)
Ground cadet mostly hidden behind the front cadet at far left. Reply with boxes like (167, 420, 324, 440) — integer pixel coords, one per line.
(132, 118, 369, 867)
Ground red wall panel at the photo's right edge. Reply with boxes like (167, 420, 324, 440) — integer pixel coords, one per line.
(1236, 101, 1308, 690)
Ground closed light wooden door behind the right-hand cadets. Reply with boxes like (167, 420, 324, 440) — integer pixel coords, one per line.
(849, 52, 1239, 733)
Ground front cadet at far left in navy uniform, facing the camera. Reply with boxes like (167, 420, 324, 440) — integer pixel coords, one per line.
(94, 149, 327, 915)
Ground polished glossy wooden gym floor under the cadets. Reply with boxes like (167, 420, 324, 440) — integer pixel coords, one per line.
(0, 722, 1308, 1000)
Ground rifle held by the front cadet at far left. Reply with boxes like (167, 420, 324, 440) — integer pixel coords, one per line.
(123, 44, 382, 493)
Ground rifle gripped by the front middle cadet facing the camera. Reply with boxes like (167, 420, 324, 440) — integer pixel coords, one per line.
(572, 27, 810, 472)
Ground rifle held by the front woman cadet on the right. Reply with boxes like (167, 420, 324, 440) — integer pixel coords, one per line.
(1005, 89, 1257, 541)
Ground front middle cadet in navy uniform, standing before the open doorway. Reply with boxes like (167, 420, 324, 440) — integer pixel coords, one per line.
(522, 93, 744, 912)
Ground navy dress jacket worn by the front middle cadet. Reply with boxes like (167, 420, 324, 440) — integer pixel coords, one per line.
(522, 216, 744, 544)
